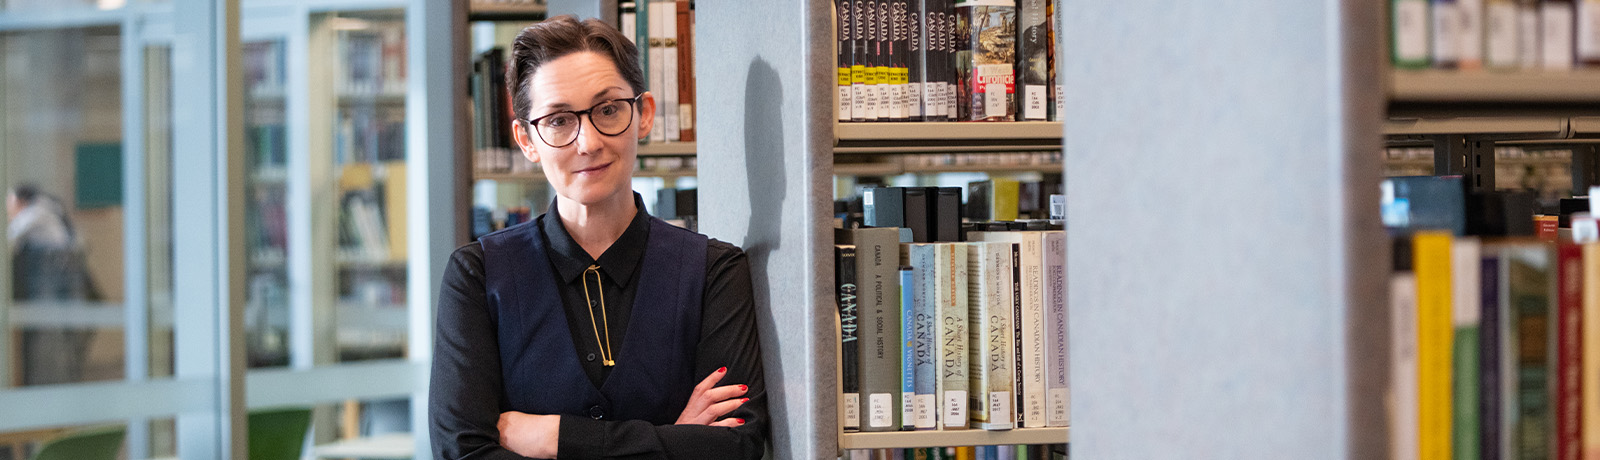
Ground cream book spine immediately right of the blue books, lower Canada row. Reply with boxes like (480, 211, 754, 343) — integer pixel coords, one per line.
(933, 243, 971, 430)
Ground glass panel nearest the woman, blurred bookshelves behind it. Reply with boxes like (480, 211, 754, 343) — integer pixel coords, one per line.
(312, 10, 406, 364)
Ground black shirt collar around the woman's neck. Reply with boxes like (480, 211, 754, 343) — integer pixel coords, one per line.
(538, 193, 650, 288)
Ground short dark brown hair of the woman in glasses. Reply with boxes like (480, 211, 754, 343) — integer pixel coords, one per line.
(506, 14, 645, 120)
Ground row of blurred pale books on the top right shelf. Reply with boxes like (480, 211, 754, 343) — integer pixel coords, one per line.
(1389, 0, 1600, 70)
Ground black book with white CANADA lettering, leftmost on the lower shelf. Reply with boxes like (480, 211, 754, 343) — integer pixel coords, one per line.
(834, 244, 861, 431)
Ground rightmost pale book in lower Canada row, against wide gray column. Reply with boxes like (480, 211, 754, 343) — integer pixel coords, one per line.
(1045, 230, 1072, 426)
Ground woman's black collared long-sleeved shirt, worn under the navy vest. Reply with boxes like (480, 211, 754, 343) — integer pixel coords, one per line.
(429, 193, 768, 458)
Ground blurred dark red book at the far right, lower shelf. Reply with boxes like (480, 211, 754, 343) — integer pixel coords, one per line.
(1552, 243, 1584, 460)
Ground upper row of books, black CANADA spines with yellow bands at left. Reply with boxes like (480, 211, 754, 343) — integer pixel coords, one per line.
(834, 0, 1064, 121)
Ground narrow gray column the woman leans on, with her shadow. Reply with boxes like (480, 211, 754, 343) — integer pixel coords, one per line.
(694, 0, 838, 458)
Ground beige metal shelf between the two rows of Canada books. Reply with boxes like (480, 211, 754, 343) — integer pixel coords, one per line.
(834, 121, 1061, 155)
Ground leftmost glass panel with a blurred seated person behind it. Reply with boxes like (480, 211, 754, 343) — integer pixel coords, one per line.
(0, 27, 125, 385)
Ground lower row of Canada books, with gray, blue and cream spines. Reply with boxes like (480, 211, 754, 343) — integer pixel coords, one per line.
(835, 222, 1069, 431)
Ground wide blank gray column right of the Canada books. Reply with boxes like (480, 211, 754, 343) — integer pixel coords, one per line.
(1058, 0, 1389, 458)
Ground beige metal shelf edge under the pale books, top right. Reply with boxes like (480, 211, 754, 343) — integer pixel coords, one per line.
(1389, 70, 1600, 105)
